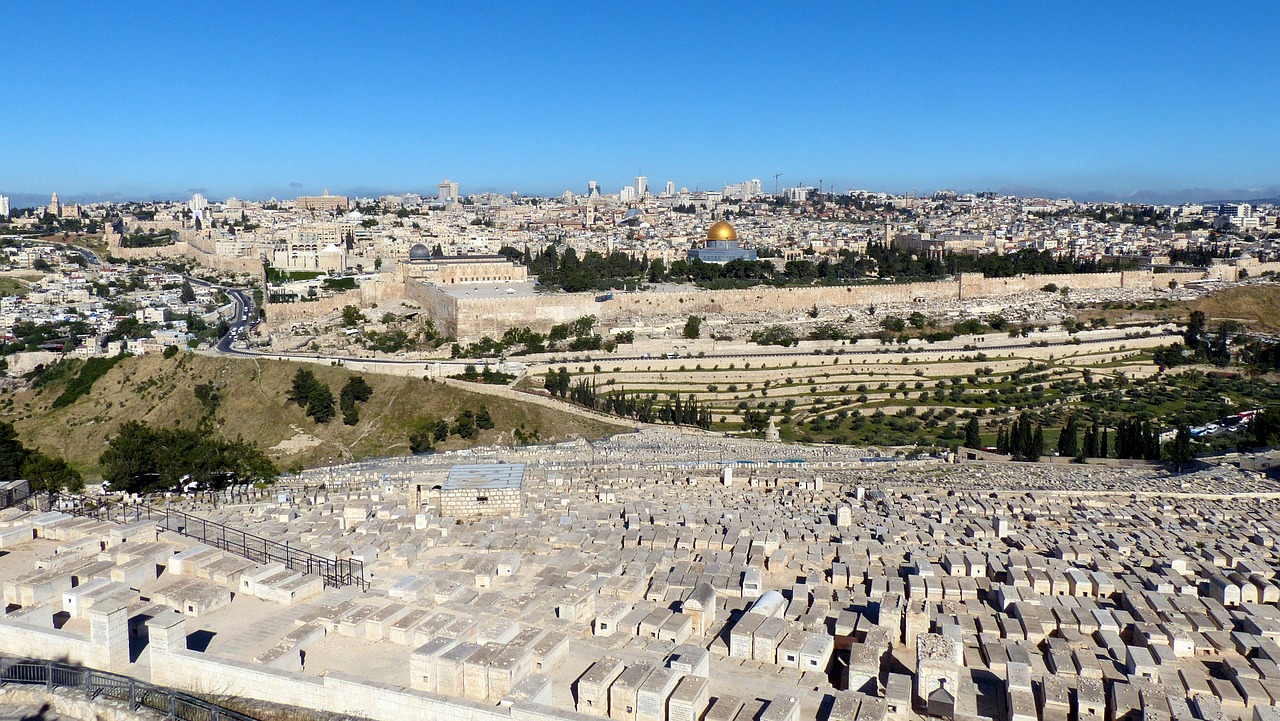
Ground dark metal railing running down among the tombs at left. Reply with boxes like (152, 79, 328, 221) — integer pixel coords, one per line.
(36, 494, 369, 590)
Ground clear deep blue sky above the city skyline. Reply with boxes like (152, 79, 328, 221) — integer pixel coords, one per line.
(0, 0, 1280, 200)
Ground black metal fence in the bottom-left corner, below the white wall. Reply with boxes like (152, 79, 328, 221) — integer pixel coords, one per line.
(0, 656, 256, 721)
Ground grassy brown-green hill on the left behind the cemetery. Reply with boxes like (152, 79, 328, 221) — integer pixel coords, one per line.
(0, 353, 622, 478)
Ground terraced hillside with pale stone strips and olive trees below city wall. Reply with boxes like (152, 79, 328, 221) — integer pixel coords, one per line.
(524, 329, 1268, 447)
